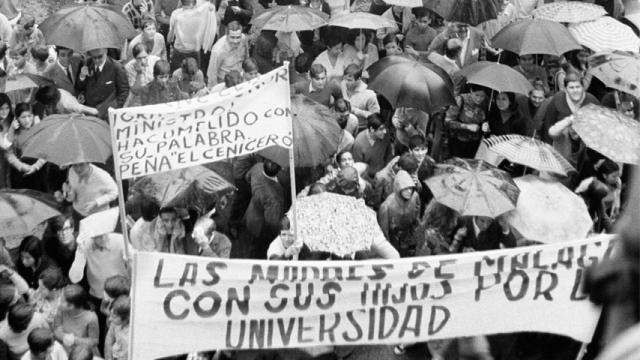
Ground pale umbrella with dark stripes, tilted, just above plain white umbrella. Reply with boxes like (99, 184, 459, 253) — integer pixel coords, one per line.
(483, 135, 575, 176)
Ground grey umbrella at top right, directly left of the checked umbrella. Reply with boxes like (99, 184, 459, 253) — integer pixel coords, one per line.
(491, 19, 581, 56)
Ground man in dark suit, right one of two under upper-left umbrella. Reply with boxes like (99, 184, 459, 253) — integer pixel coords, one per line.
(76, 49, 129, 119)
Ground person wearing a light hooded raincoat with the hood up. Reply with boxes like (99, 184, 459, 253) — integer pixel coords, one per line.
(378, 170, 420, 257)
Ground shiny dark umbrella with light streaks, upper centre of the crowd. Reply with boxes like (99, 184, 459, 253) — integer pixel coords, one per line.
(367, 56, 455, 113)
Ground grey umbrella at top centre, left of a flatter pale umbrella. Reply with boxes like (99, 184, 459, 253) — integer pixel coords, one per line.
(251, 5, 329, 32)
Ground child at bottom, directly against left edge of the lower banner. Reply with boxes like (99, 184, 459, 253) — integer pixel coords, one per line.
(104, 296, 131, 360)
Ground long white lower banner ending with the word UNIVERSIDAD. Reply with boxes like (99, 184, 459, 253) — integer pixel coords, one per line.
(131, 236, 614, 359)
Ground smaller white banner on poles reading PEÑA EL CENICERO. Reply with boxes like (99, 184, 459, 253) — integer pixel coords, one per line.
(109, 67, 293, 179)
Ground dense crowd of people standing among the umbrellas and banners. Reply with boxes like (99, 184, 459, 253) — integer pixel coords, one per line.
(0, 0, 640, 360)
